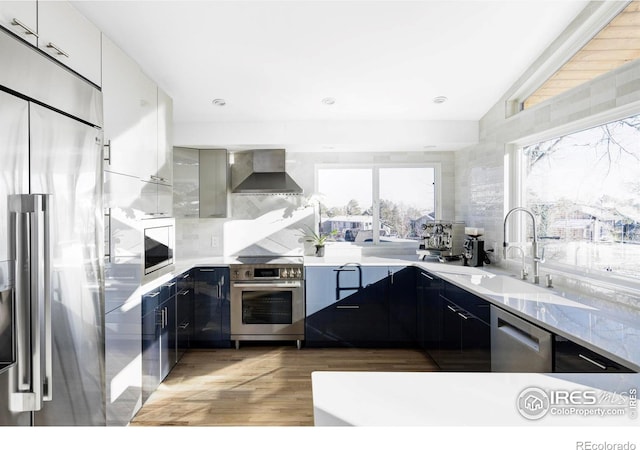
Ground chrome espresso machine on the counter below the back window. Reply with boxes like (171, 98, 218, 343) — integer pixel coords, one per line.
(417, 220, 464, 262)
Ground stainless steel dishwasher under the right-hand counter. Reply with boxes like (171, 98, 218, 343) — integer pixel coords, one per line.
(491, 305, 553, 373)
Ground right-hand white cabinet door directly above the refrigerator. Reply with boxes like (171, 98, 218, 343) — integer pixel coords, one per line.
(38, 1, 101, 86)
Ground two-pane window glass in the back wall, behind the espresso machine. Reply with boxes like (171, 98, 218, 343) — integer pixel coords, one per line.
(317, 167, 435, 242)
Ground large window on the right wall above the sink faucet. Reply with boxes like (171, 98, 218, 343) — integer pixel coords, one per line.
(523, 115, 640, 280)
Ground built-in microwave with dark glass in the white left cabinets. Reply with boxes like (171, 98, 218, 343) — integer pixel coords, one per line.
(142, 218, 175, 280)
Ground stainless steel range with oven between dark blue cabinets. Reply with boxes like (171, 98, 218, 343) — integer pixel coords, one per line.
(230, 256, 305, 348)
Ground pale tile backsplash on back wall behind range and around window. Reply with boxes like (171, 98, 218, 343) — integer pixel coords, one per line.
(176, 152, 455, 259)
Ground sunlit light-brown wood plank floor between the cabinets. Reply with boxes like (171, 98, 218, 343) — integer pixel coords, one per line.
(131, 343, 438, 426)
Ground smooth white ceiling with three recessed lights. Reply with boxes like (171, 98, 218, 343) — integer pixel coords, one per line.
(72, 0, 588, 123)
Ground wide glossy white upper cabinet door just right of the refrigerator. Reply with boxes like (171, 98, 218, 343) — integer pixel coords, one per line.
(102, 36, 157, 180)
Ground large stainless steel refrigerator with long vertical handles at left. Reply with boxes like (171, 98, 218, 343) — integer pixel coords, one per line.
(0, 30, 105, 426)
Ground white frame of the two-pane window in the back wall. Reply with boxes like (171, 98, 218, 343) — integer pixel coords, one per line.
(314, 162, 442, 248)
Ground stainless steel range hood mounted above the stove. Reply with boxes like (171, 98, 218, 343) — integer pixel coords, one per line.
(232, 149, 302, 194)
